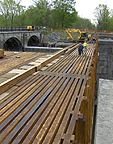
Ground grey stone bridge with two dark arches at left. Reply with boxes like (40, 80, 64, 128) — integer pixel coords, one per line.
(0, 31, 43, 51)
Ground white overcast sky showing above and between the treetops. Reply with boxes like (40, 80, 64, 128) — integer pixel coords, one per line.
(21, 0, 113, 22)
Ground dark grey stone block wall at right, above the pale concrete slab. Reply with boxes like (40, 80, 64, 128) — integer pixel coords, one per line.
(96, 39, 113, 97)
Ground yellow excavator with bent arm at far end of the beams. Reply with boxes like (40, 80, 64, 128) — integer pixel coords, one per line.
(66, 29, 91, 42)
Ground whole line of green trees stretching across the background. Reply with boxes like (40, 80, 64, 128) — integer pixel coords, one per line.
(0, 0, 113, 31)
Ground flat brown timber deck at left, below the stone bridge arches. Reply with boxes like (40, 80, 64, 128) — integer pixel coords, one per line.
(0, 51, 47, 76)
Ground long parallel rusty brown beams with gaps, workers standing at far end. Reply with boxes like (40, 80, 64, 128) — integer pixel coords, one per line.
(0, 44, 94, 144)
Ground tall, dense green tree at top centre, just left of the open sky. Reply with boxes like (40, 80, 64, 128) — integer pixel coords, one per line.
(53, 0, 77, 28)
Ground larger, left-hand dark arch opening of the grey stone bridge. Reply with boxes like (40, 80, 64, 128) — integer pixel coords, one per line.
(3, 37, 22, 51)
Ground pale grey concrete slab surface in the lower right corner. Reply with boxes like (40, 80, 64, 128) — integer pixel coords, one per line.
(94, 79, 113, 144)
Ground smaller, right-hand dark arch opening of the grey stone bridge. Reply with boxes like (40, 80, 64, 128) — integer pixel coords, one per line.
(27, 35, 40, 46)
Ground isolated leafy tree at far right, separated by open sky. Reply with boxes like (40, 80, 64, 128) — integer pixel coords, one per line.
(94, 4, 110, 30)
